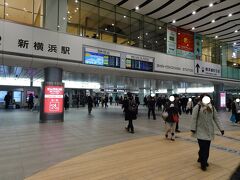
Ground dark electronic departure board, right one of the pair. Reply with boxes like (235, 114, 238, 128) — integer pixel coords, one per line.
(125, 58, 153, 71)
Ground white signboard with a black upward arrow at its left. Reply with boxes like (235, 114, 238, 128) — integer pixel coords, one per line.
(194, 60, 221, 77)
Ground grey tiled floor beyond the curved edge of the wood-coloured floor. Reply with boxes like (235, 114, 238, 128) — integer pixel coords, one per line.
(0, 106, 240, 180)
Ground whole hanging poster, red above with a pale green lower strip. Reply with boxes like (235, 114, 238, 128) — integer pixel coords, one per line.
(177, 28, 194, 59)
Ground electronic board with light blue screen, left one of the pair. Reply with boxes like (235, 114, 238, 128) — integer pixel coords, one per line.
(84, 51, 120, 68)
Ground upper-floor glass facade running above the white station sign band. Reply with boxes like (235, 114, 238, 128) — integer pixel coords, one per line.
(0, 0, 240, 79)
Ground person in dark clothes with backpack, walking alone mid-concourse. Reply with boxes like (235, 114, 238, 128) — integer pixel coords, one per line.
(123, 93, 137, 133)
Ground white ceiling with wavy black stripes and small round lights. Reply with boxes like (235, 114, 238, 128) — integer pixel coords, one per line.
(104, 0, 240, 43)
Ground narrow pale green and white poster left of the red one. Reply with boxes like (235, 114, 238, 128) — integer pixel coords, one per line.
(167, 26, 177, 56)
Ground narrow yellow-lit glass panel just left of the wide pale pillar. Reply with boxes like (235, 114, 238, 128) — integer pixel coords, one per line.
(33, 0, 43, 27)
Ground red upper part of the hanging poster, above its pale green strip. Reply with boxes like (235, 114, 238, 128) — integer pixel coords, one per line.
(177, 29, 194, 52)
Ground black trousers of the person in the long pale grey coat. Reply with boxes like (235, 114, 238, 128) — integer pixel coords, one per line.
(198, 139, 211, 167)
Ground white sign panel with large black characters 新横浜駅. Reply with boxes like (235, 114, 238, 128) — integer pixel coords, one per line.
(0, 22, 82, 61)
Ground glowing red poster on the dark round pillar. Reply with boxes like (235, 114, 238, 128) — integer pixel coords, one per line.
(44, 86, 64, 113)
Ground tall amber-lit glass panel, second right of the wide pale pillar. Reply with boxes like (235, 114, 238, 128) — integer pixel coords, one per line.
(80, 2, 99, 38)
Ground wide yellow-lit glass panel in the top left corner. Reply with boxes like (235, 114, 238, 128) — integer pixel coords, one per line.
(5, 0, 33, 25)
